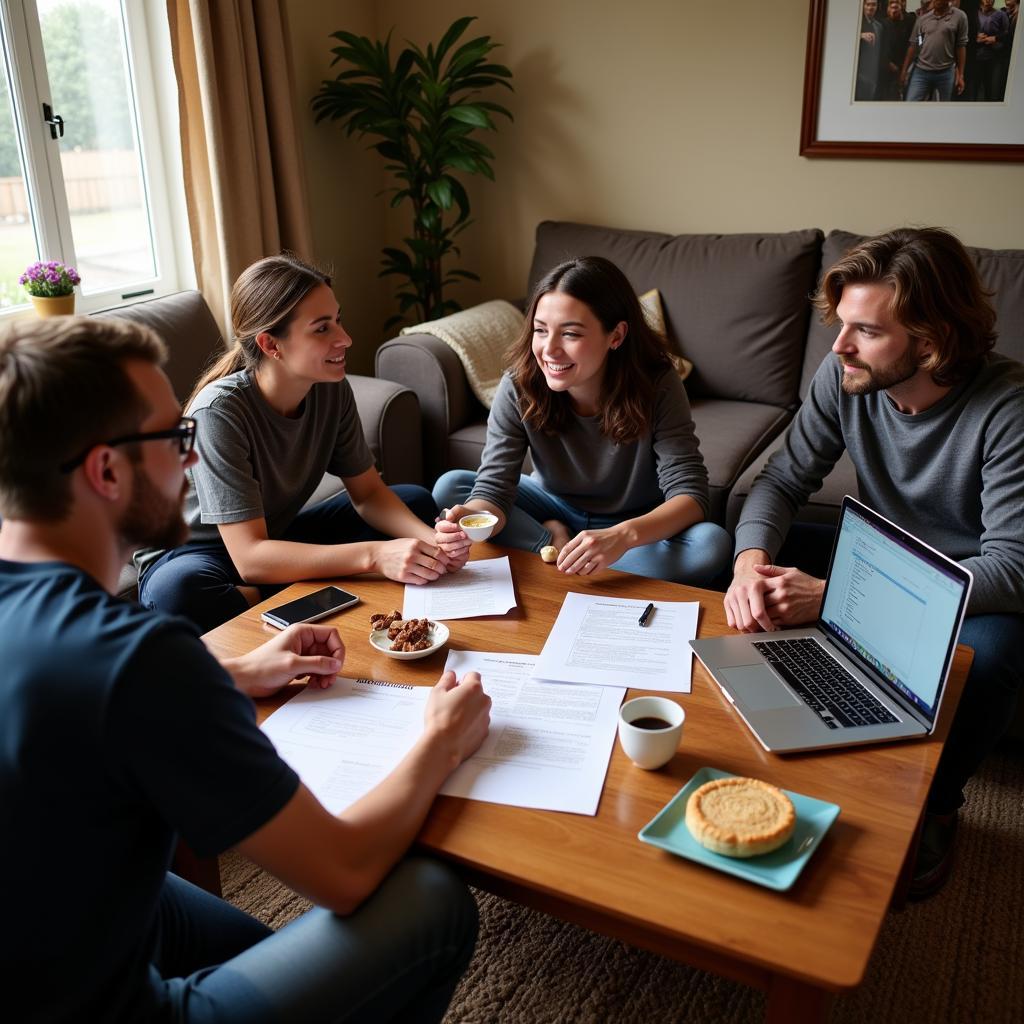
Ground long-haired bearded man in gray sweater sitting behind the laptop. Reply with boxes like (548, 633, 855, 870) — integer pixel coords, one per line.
(725, 228, 1024, 898)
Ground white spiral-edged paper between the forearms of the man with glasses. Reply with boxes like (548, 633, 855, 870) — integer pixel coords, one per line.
(263, 678, 430, 814)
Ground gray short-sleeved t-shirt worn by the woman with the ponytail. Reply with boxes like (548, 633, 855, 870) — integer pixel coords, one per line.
(135, 370, 374, 570)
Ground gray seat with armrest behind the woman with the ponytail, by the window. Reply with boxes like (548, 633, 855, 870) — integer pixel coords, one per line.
(95, 292, 423, 594)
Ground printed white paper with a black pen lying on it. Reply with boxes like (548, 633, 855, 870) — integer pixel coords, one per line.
(537, 594, 700, 693)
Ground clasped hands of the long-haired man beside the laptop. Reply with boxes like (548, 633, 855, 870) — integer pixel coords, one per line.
(724, 562, 824, 633)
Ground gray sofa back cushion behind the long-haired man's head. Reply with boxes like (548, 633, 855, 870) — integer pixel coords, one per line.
(800, 231, 1024, 399)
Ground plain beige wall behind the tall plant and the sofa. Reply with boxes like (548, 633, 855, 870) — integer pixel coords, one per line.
(290, 0, 1024, 362)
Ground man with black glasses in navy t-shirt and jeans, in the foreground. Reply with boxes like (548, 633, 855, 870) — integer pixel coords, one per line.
(0, 317, 490, 1024)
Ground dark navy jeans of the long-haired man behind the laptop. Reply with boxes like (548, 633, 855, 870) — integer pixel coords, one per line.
(775, 523, 1024, 814)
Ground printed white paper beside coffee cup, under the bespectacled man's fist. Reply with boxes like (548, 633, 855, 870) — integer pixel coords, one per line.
(441, 650, 626, 814)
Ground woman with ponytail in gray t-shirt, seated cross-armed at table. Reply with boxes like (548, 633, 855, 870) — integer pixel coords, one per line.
(136, 255, 447, 631)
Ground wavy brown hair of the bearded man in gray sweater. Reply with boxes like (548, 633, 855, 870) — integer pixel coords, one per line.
(814, 227, 996, 387)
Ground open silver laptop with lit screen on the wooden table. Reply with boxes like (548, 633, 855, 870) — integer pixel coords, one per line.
(690, 496, 972, 752)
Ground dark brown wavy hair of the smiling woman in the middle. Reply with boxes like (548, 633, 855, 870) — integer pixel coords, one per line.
(508, 256, 672, 444)
